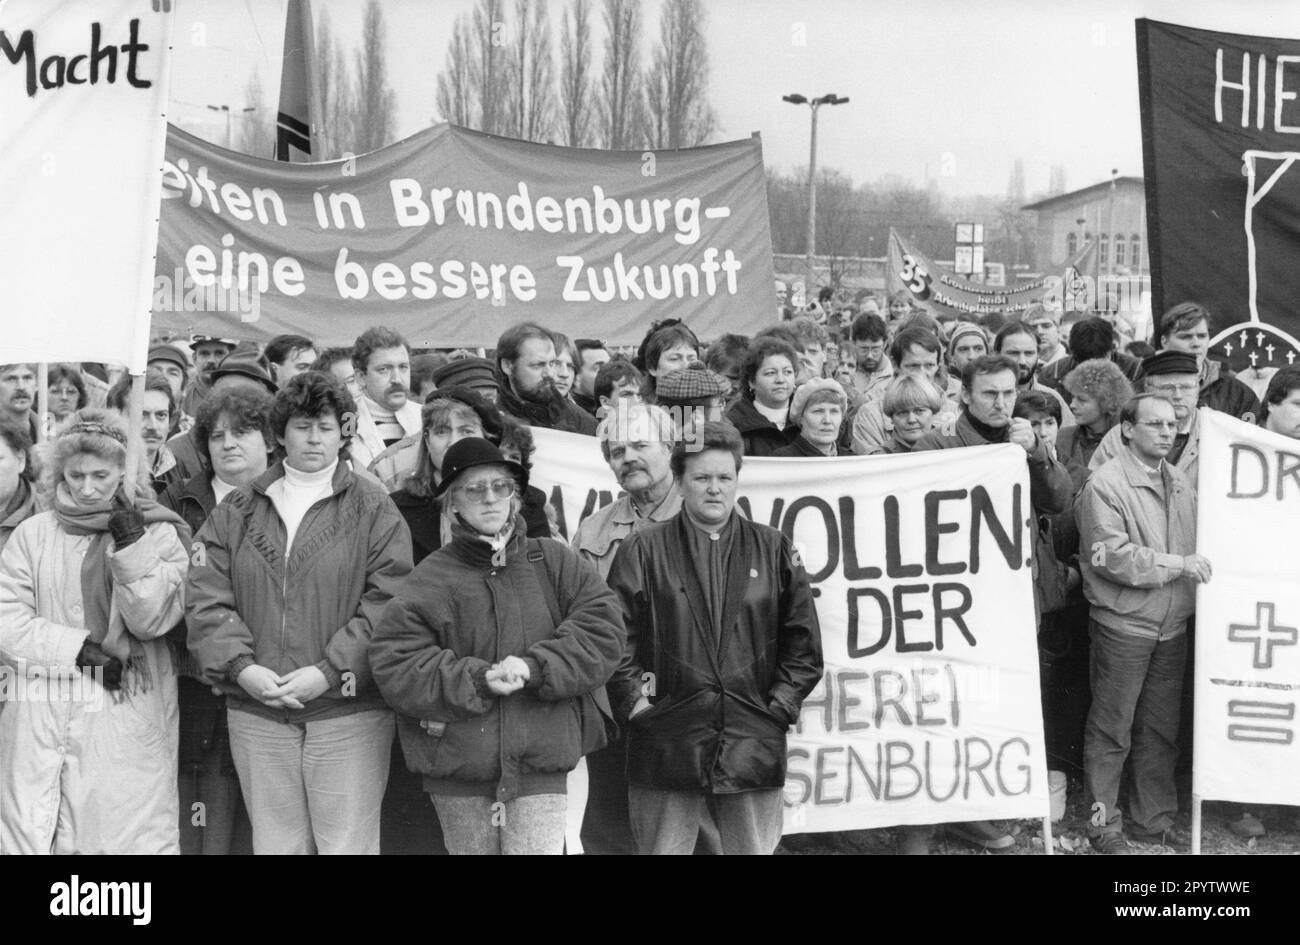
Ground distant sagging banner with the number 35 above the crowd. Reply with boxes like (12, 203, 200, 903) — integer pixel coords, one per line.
(885, 229, 1066, 320)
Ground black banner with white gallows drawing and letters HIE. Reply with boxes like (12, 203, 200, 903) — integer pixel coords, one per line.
(1136, 19, 1300, 382)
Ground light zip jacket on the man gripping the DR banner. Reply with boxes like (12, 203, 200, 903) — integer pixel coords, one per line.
(1076, 448, 1196, 640)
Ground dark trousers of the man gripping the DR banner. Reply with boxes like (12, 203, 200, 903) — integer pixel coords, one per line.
(1083, 620, 1187, 836)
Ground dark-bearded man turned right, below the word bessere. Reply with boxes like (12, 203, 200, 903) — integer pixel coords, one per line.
(497, 321, 595, 435)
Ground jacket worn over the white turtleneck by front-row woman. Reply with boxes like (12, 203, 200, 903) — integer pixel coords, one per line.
(186, 461, 411, 721)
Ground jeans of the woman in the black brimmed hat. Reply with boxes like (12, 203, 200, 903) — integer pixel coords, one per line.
(433, 794, 568, 857)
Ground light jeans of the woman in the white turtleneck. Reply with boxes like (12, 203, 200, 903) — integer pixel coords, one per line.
(226, 708, 395, 854)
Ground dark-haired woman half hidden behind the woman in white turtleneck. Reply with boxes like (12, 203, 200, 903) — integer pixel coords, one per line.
(159, 387, 276, 857)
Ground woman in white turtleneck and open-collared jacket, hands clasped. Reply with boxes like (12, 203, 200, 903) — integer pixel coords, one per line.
(186, 370, 411, 854)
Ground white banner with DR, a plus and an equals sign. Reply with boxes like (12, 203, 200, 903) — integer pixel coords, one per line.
(1192, 408, 1300, 803)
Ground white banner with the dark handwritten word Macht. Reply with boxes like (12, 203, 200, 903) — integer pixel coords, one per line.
(0, 0, 172, 373)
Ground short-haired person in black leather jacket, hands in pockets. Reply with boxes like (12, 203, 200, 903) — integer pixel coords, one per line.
(608, 421, 823, 854)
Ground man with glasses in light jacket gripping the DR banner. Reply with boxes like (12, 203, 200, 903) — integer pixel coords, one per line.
(1076, 395, 1210, 854)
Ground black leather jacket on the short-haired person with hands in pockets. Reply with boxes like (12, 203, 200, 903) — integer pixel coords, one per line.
(608, 512, 822, 794)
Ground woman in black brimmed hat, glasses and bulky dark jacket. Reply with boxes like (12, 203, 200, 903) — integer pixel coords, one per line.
(371, 438, 625, 854)
